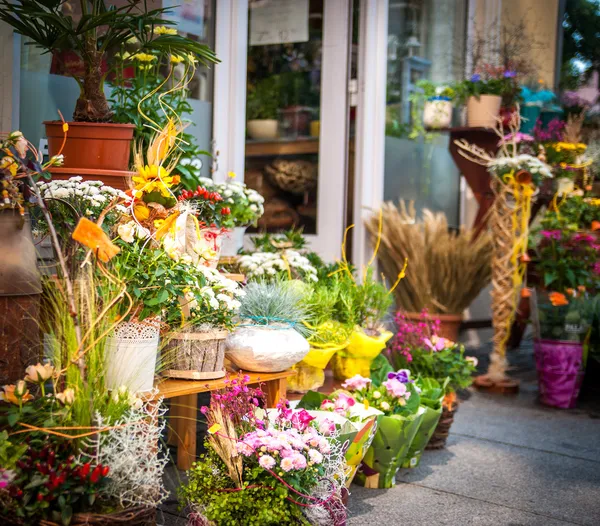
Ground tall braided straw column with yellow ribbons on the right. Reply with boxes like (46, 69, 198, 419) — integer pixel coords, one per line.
(488, 177, 526, 382)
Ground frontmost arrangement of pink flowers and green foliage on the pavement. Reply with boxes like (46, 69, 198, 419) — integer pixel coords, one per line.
(179, 376, 346, 526)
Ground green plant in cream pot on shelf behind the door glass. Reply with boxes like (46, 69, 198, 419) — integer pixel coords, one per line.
(246, 75, 280, 140)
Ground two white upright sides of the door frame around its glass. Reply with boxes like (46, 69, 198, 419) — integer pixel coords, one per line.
(213, 0, 352, 261)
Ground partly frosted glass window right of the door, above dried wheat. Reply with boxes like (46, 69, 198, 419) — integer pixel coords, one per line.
(384, 0, 467, 225)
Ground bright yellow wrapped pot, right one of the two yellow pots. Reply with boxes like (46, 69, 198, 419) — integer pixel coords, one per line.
(331, 329, 393, 380)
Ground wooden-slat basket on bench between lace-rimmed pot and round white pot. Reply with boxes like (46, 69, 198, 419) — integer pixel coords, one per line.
(166, 330, 228, 380)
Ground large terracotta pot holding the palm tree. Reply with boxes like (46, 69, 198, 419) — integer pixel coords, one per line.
(44, 121, 135, 190)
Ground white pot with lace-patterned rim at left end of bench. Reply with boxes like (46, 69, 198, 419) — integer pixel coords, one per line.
(104, 319, 160, 393)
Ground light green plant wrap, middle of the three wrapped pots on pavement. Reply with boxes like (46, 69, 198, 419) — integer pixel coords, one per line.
(354, 407, 425, 489)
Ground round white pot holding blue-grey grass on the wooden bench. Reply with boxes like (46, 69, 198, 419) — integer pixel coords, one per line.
(225, 326, 310, 373)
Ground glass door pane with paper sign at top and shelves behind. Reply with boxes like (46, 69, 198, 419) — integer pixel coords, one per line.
(244, 0, 323, 234)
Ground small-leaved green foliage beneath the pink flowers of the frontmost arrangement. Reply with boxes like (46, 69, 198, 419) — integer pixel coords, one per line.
(178, 445, 309, 526)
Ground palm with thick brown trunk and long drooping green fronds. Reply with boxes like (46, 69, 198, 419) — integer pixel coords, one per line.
(0, 0, 217, 122)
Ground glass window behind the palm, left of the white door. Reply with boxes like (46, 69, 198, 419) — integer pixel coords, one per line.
(20, 0, 215, 177)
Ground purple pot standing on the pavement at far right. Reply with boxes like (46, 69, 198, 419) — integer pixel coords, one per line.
(534, 340, 585, 409)
